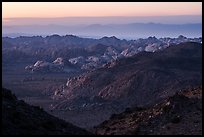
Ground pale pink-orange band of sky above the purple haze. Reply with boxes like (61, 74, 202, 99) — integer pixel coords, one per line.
(2, 2, 202, 21)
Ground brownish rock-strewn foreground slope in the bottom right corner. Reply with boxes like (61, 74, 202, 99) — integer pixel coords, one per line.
(95, 87, 202, 135)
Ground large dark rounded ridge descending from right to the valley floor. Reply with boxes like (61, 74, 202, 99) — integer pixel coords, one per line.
(53, 42, 202, 109)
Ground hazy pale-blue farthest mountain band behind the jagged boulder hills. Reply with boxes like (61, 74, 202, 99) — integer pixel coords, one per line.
(2, 23, 202, 39)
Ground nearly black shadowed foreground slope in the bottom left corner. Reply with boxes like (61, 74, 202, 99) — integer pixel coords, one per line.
(2, 88, 90, 135)
